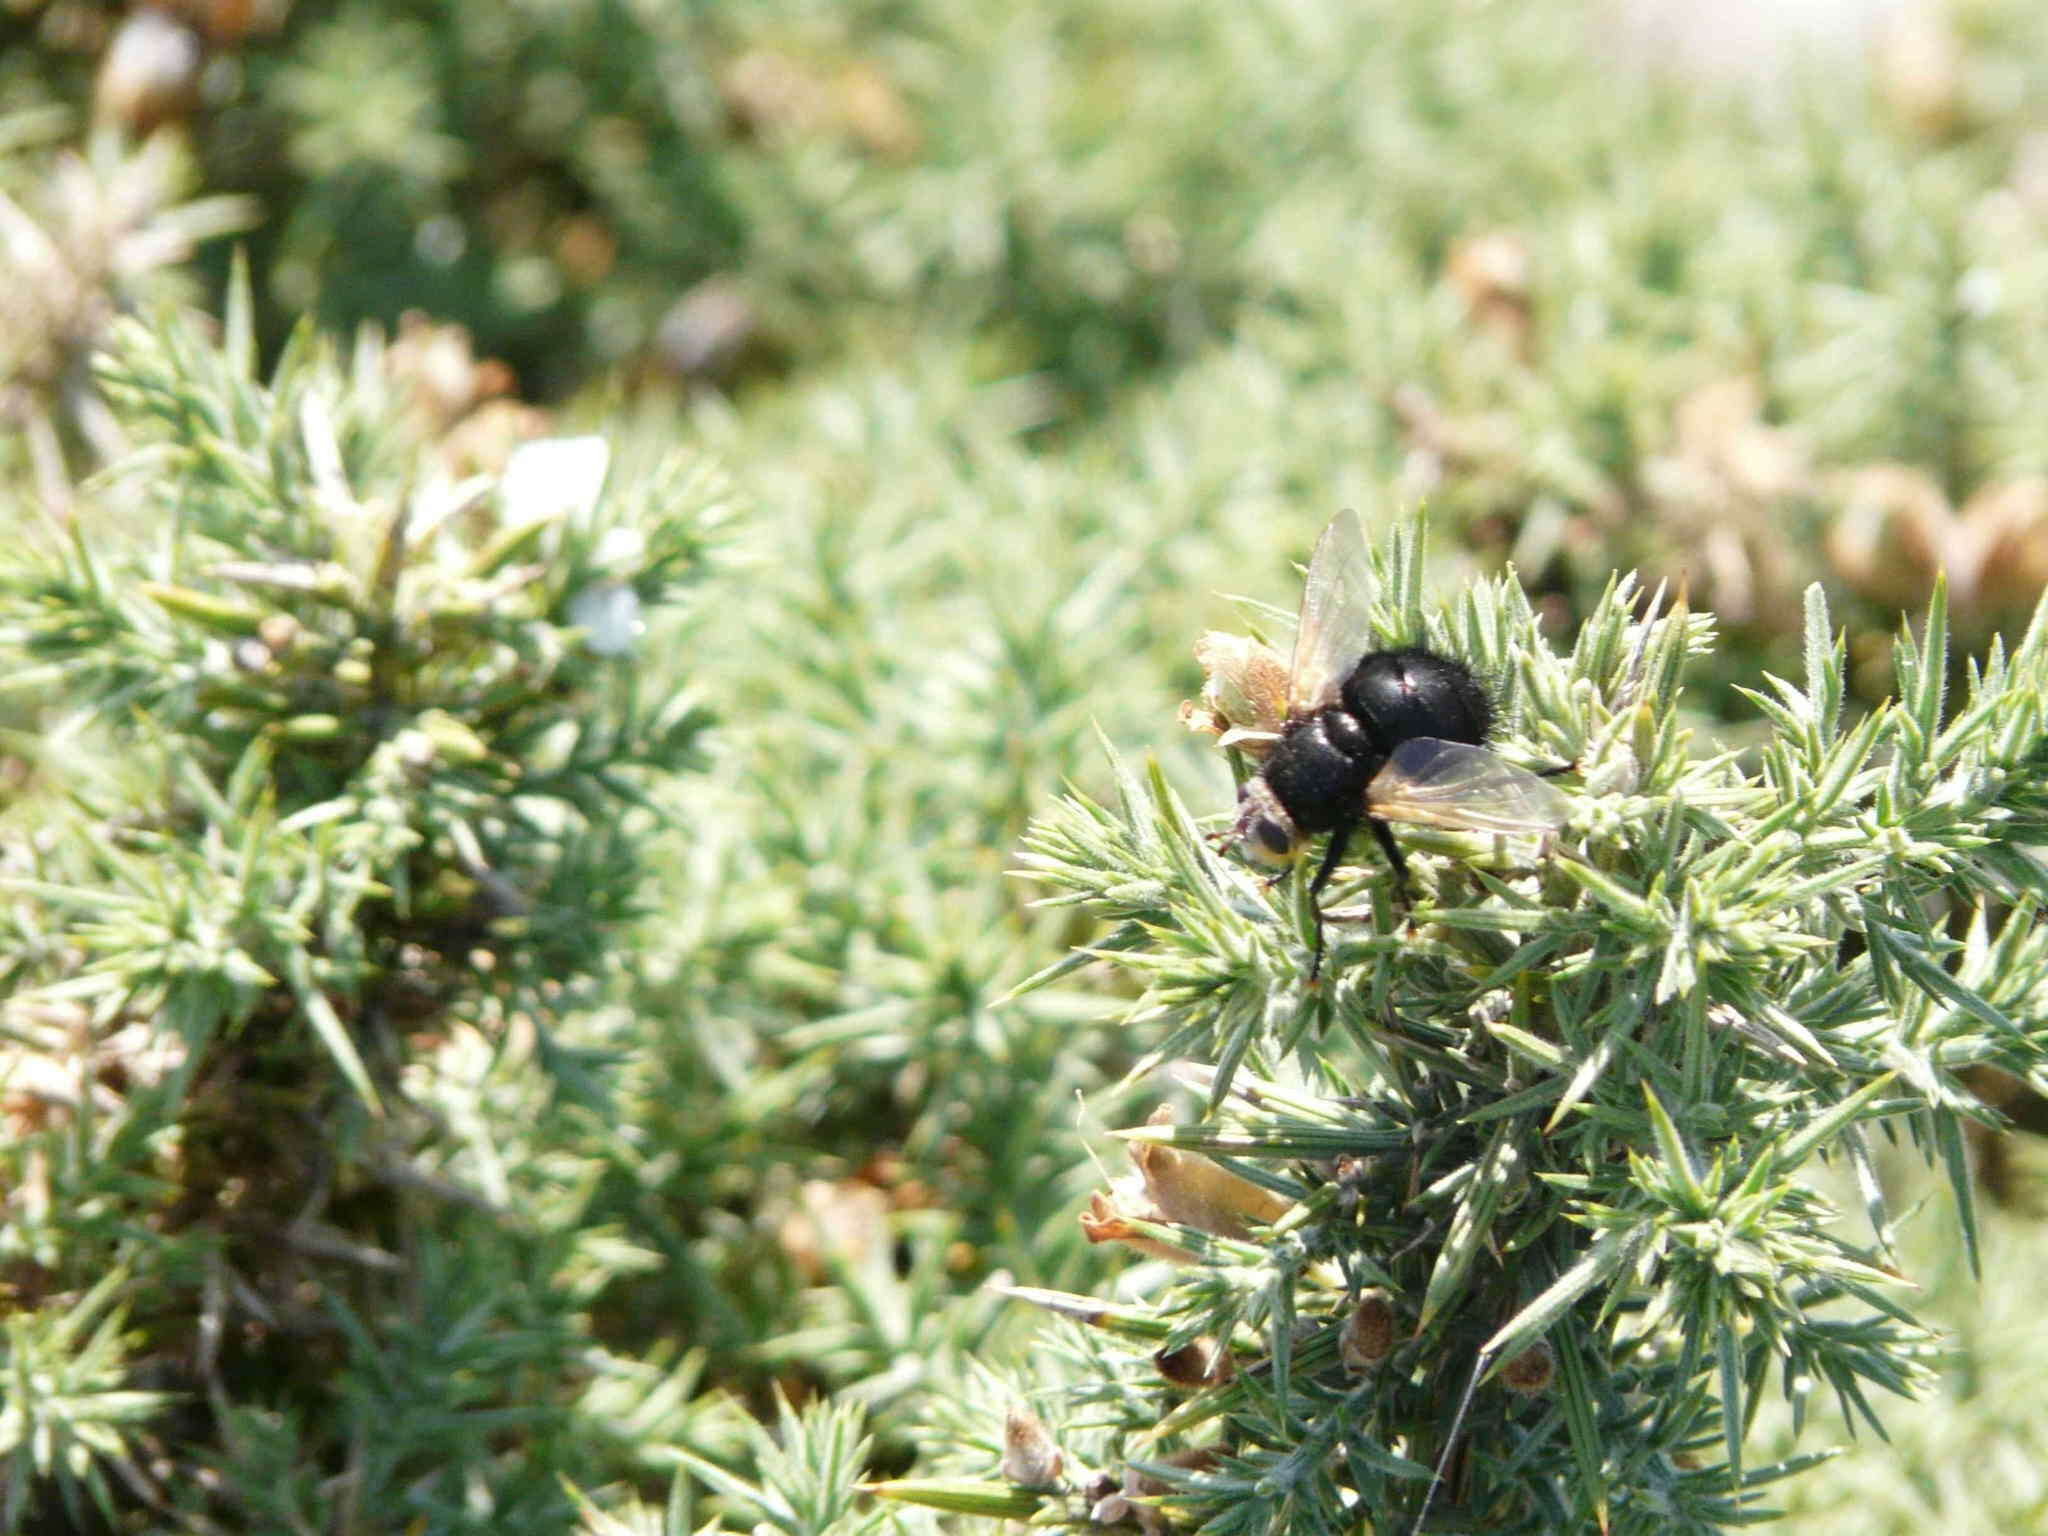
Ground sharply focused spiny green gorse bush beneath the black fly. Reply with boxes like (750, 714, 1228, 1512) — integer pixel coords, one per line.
(891, 528, 2048, 1532)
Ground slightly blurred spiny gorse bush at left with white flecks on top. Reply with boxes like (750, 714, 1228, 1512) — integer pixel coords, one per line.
(0, 295, 725, 1530)
